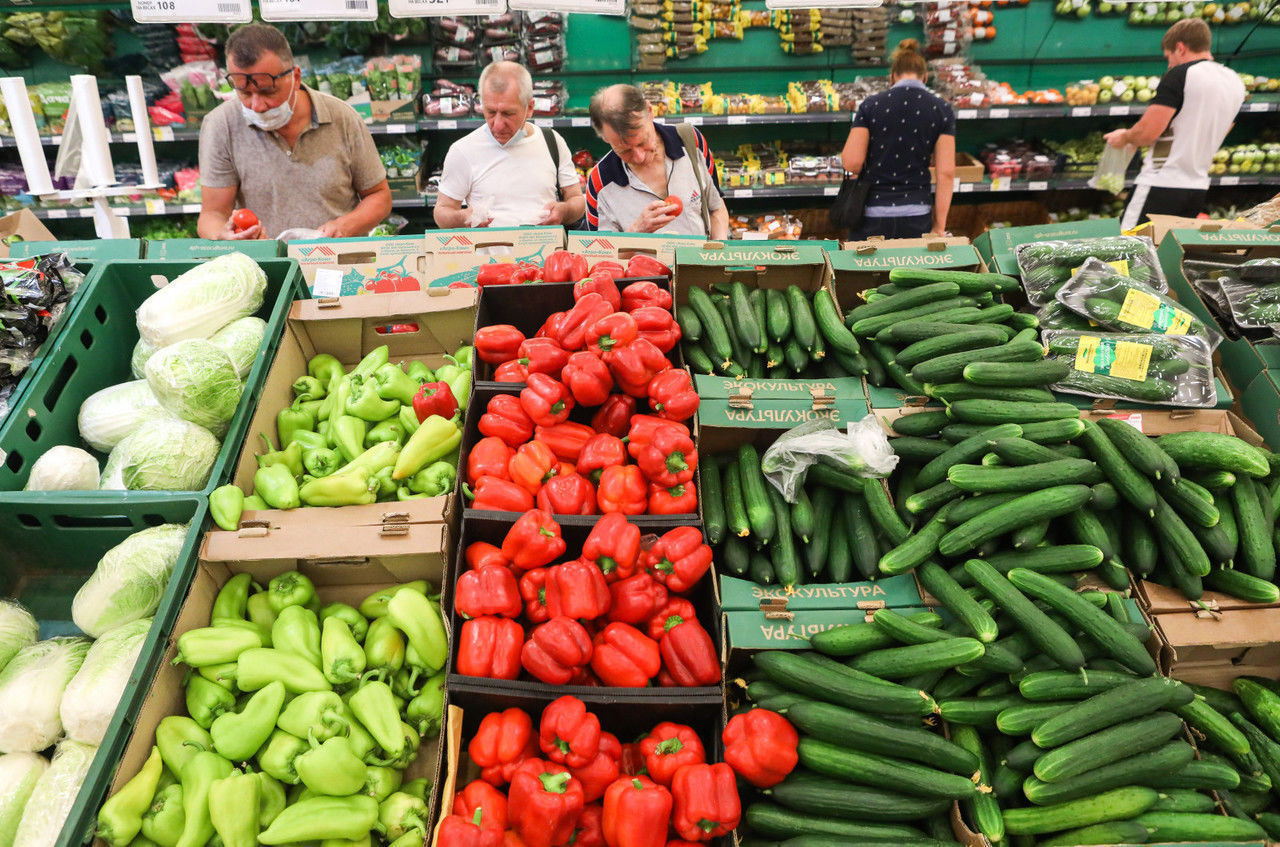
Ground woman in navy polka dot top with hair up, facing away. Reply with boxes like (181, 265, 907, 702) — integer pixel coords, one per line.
(840, 38, 956, 241)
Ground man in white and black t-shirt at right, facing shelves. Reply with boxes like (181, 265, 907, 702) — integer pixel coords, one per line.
(1106, 18, 1244, 229)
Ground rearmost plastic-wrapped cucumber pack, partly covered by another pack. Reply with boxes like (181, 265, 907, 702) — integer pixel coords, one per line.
(1014, 235, 1169, 306)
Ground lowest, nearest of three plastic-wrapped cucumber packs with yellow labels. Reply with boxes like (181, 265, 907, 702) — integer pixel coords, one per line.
(1044, 330, 1217, 408)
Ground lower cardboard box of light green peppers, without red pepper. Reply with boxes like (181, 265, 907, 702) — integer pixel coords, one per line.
(97, 525, 447, 844)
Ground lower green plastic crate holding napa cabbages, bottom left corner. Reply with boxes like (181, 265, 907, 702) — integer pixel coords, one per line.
(0, 494, 207, 847)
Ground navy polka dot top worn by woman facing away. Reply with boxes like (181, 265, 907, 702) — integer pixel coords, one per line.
(854, 79, 956, 209)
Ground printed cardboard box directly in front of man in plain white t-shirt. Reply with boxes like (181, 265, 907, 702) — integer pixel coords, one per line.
(422, 226, 564, 288)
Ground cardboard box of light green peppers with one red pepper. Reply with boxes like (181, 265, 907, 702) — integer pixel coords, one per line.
(224, 290, 476, 534)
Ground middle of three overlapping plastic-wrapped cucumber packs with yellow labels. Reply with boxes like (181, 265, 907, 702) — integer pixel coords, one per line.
(1057, 258, 1222, 349)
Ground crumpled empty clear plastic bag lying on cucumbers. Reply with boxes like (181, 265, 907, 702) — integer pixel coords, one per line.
(760, 415, 897, 503)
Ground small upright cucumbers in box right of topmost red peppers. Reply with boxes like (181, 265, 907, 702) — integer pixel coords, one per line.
(676, 281, 867, 379)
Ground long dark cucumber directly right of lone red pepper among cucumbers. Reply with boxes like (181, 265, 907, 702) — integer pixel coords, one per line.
(796, 737, 978, 800)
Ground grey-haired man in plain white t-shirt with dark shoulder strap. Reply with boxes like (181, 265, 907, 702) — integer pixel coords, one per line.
(434, 61, 585, 229)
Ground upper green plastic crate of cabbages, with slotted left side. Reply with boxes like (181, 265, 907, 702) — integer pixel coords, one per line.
(0, 258, 306, 504)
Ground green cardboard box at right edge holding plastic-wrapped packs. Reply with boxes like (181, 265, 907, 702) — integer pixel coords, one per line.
(1157, 229, 1280, 389)
